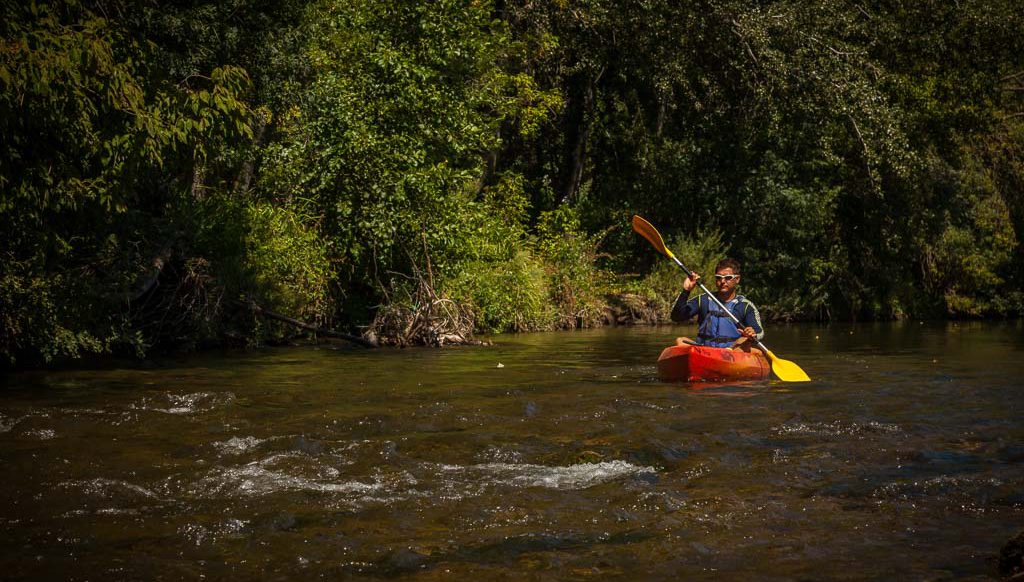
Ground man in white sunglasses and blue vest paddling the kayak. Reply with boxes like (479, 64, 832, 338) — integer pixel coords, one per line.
(672, 258, 765, 349)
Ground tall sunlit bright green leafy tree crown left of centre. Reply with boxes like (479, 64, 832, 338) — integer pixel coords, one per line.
(265, 1, 540, 280)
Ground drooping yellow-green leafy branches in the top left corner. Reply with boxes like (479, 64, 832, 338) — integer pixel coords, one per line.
(0, 3, 252, 219)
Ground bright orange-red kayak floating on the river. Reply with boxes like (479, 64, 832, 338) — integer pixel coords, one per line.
(657, 344, 771, 382)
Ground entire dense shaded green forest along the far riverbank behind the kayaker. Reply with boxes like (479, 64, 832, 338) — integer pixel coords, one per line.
(0, 0, 1024, 366)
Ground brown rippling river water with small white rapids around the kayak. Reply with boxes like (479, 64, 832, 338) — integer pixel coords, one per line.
(0, 322, 1024, 580)
